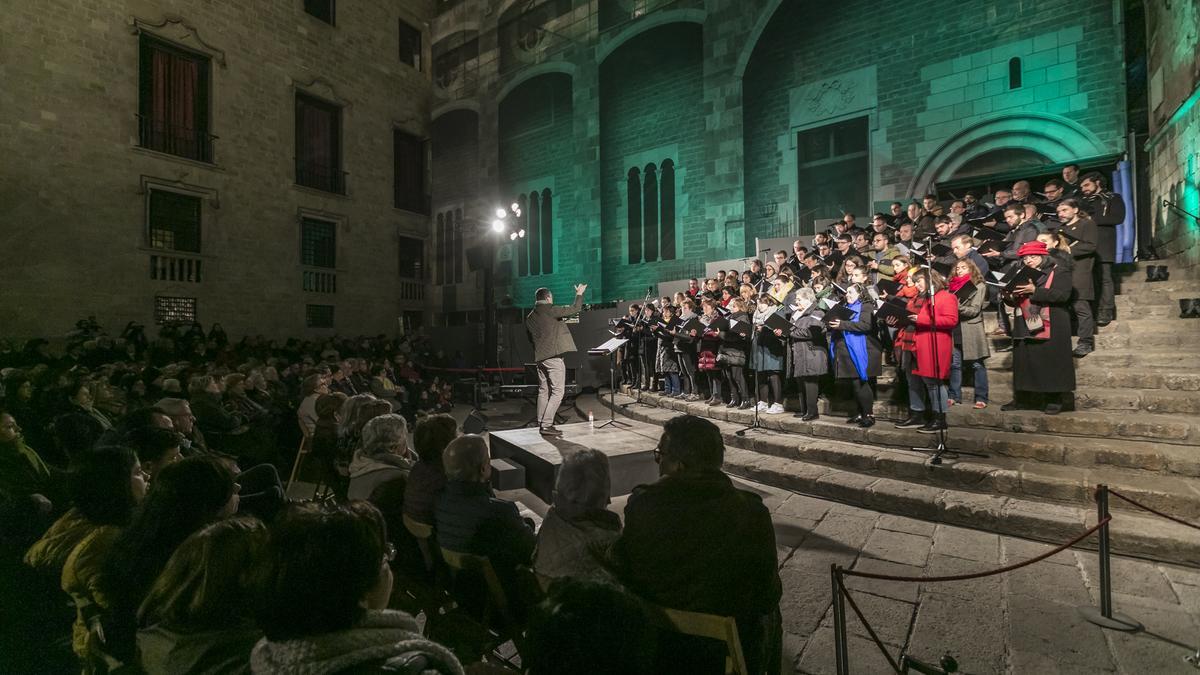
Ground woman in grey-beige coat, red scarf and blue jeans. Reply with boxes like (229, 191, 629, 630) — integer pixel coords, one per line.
(947, 258, 991, 410)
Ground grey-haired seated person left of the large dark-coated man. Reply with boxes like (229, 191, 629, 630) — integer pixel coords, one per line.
(533, 448, 620, 580)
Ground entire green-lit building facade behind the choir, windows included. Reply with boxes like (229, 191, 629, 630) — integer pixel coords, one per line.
(432, 0, 1128, 311)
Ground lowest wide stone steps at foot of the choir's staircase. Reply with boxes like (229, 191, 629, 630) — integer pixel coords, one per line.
(605, 396, 1200, 565)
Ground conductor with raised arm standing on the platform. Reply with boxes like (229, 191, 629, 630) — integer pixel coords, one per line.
(526, 283, 588, 437)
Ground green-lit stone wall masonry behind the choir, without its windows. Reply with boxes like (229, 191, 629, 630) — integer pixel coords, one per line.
(433, 0, 1127, 309)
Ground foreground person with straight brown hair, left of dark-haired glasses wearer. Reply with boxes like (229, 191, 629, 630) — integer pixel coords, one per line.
(137, 518, 266, 675)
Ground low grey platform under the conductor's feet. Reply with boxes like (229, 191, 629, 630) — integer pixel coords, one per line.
(488, 419, 662, 503)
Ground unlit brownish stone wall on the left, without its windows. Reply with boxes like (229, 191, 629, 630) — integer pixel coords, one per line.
(0, 0, 433, 336)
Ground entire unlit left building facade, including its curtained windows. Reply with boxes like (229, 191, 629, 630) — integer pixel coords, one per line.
(0, 0, 433, 336)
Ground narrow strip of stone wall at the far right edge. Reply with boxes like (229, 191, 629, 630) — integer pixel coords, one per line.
(1146, 0, 1200, 267)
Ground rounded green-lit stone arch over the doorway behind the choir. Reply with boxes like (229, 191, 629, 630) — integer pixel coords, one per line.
(907, 113, 1111, 195)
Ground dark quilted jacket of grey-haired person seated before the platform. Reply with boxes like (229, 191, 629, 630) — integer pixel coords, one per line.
(436, 480, 534, 574)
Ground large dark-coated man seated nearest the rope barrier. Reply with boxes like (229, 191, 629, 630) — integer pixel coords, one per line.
(612, 414, 782, 673)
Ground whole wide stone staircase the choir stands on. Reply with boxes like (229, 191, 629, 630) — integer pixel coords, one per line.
(604, 257, 1200, 565)
